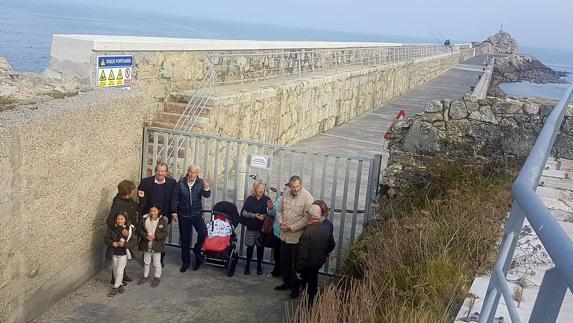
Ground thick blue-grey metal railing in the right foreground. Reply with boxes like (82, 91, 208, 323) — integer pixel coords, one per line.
(479, 86, 573, 323)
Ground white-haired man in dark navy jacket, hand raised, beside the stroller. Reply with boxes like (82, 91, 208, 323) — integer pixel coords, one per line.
(171, 165, 211, 273)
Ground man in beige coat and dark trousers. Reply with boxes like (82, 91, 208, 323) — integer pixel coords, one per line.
(275, 175, 314, 298)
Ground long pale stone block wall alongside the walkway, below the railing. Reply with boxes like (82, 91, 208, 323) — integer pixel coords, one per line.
(202, 53, 470, 145)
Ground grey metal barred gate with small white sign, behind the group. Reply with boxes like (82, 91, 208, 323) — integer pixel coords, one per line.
(141, 127, 382, 273)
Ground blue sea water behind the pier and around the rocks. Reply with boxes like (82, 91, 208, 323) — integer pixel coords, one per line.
(0, 0, 573, 98)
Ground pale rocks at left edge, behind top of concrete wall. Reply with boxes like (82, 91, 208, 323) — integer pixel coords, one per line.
(0, 57, 82, 111)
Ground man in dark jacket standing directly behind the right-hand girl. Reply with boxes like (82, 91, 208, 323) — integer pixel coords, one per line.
(137, 162, 177, 267)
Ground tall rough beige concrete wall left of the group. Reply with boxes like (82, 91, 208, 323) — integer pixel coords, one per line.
(0, 91, 158, 322)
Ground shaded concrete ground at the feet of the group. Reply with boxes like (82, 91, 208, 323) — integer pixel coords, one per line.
(36, 248, 292, 323)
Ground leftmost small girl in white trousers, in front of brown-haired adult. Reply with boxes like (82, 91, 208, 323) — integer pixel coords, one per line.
(105, 212, 135, 297)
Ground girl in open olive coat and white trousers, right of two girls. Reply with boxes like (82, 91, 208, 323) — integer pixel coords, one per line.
(137, 205, 167, 287)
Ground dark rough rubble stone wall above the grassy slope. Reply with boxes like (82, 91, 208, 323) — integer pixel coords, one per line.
(383, 96, 573, 195)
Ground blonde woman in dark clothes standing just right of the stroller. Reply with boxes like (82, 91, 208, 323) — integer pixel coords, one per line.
(241, 181, 272, 275)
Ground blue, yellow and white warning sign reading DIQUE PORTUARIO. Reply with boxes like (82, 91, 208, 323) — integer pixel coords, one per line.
(97, 55, 133, 87)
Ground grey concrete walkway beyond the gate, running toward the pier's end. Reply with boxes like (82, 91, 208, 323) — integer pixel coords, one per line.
(295, 56, 486, 166)
